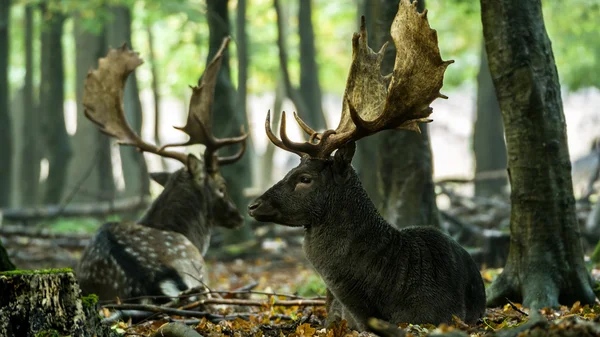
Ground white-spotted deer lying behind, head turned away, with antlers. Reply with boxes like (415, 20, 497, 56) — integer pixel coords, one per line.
(77, 37, 248, 302)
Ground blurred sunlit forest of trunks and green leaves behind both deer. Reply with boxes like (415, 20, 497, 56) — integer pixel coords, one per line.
(0, 0, 600, 255)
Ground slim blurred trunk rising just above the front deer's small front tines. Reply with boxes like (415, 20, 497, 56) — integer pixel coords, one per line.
(298, 0, 327, 130)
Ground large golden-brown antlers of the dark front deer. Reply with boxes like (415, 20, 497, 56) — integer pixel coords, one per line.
(265, 0, 454, 158)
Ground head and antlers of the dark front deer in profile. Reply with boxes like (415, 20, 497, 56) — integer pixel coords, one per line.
(248, 0, 454, 227)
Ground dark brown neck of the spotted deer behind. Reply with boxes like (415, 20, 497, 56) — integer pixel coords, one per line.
(139, 185, 211, 255)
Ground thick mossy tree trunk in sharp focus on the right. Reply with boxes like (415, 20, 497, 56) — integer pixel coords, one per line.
(481, 0, 595, 309)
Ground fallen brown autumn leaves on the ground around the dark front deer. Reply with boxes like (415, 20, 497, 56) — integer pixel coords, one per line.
(101, 258, 600, 337)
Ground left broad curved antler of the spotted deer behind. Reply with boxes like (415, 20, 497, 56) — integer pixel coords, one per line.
(83, 44, 187, 163)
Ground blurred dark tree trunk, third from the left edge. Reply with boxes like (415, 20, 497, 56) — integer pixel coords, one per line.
(40, 3, 72, 204)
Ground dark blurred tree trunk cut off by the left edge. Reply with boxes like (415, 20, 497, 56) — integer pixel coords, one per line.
(0, 0, 13, 207)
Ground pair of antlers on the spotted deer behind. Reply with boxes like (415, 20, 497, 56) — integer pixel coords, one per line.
(83, 37, 248, 170)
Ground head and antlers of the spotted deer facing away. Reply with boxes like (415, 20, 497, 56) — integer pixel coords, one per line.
(83, 37, 248, 228)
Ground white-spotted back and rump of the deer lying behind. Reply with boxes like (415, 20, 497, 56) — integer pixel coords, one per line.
(77, 222, 205, 302)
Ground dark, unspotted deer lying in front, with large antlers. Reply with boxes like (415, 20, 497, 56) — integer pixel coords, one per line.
(248, 0, 485, 330)
